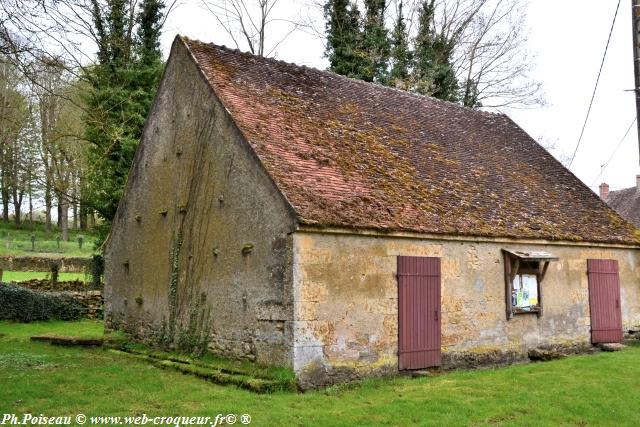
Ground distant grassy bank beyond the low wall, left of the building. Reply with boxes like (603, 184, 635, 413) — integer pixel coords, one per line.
(0, 222, 95, 257)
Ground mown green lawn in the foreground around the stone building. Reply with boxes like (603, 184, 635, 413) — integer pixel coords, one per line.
(0, 321, 640, 426)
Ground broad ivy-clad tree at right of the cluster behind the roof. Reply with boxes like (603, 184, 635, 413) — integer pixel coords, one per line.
(412, 0, 458, 102)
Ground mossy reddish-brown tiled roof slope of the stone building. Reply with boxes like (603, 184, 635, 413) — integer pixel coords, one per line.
(181, 38, 640, 244)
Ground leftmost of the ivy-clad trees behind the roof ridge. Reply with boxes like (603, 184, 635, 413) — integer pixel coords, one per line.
(324, 0, 364, 78)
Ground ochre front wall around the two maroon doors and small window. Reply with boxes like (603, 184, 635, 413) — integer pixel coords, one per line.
(293, 232, 640, 386)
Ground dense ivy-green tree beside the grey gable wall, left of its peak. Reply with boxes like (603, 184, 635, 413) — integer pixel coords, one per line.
(84, 0, 163, 242)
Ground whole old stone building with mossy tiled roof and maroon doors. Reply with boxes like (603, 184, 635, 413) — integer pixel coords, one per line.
(105, 37, 640, 387)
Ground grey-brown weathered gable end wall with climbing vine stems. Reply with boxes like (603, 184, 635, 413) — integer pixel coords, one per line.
(105, 41, 293, 366)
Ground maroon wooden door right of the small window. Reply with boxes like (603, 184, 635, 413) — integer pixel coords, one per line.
(587, 259, 622, 344)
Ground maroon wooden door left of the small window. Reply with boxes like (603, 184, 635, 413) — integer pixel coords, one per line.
(398, 256, 441, 369)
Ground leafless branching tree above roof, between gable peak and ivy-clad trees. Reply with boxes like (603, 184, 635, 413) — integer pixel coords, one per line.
(200, 0, 302, 56)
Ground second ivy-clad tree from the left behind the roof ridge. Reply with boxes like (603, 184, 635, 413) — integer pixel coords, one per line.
(360, 0, 391, 84)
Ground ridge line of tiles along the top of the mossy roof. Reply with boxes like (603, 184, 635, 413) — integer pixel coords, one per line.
(178, 35, 505, 117)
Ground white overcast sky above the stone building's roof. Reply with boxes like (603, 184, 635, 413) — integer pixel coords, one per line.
(163, 0, 640, 191)
